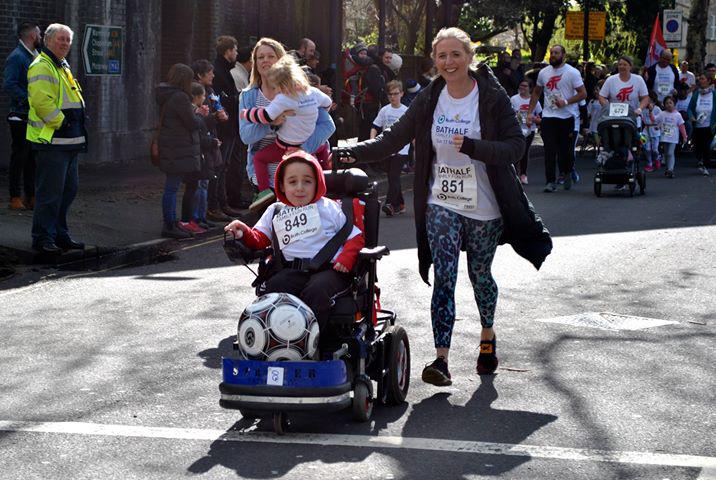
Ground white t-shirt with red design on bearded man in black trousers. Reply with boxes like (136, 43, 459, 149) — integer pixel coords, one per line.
(537, 63, 584, 118)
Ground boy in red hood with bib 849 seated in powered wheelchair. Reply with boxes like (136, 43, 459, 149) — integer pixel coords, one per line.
(224, 150, 365, 344)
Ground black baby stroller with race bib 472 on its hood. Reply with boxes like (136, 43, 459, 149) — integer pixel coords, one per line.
(594, 103, 646, 197)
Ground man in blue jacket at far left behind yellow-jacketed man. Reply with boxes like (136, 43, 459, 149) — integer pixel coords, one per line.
(3, 23, 42, 210)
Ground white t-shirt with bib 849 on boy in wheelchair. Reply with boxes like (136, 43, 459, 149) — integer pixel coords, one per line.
(254, 197, 360, 261)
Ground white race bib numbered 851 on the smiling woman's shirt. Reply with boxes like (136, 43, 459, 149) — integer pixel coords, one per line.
(432, 164, 477, 210)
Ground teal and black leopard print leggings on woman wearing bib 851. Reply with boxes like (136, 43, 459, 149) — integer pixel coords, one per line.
(425, 205, 502, 348)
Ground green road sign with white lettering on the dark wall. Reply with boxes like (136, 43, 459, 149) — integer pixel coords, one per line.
(82, 25, 124, 76)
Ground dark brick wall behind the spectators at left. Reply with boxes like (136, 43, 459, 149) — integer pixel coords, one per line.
(0, 0, 330, 168)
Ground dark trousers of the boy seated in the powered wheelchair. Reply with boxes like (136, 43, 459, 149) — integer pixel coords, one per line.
(265, 268, 351, 330)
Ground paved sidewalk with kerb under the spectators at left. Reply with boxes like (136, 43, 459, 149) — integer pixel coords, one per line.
(0, 158, 412, 278)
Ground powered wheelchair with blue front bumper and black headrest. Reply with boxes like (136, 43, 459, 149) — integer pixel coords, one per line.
(219, 154, 410, 435)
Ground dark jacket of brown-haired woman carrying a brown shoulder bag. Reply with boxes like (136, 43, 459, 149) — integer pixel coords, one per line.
(156, 83, 203, 174)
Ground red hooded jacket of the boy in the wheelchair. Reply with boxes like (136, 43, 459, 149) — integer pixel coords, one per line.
(243, 150, 365, 270)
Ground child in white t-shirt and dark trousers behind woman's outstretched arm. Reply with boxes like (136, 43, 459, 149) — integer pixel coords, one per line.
(370, 80, 410, 217)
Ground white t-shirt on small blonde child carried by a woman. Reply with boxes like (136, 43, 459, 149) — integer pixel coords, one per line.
(266, 87, 333, 145)
